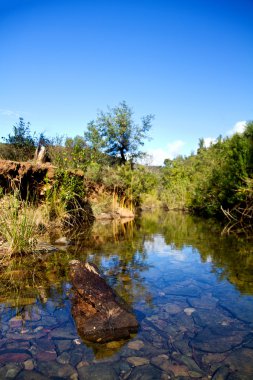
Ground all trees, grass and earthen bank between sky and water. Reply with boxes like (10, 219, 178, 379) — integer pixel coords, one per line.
(0, 102, 253, 255)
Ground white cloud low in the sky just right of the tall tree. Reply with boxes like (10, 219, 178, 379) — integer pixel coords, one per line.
(148, 140, 185, 165)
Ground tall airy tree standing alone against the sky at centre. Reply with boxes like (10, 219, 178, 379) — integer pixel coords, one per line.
(84, 102, 153, 165)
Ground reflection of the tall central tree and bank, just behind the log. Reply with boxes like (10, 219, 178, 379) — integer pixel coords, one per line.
(68, 220, 150, 304)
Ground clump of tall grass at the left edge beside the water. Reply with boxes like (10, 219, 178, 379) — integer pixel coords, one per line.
(0, 193, 37, 257)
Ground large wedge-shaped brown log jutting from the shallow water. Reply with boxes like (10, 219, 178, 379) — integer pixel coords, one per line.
(70, 260, 138, 343)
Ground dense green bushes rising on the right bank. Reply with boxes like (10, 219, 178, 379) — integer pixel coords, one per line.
(161, 123, 253, 223)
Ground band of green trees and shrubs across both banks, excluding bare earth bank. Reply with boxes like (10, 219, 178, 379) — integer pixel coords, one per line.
(0, 102, 253, 232)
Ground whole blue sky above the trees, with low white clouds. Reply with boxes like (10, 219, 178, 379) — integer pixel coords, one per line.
(0, 0, 253, 163)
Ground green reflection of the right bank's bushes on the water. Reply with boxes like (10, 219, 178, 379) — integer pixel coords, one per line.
(142, 212, 253, 294)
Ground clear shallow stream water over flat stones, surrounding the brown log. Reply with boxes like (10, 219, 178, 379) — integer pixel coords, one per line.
(0, 213, 253, 380)
